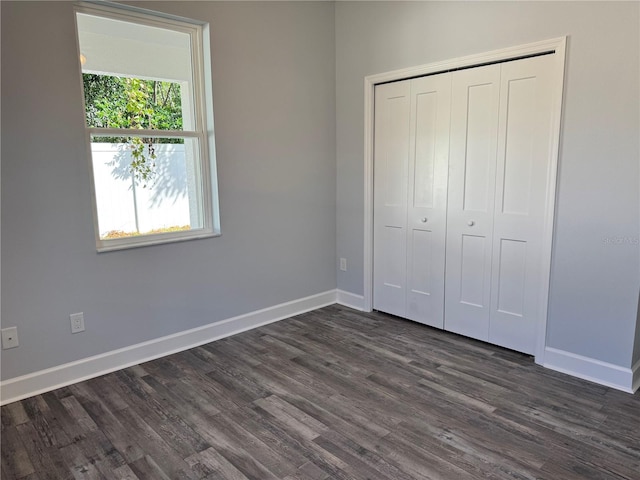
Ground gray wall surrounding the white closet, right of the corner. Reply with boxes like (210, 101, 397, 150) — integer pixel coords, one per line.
(336, 2, 640, 367)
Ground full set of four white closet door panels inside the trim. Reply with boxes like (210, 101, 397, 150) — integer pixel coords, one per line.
(373, 55, 555, 354)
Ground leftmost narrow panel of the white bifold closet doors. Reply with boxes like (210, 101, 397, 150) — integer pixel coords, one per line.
(373, 80, 411, 316)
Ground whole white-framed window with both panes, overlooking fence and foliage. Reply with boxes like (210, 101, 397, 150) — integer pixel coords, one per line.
(76, 4, 219, 251)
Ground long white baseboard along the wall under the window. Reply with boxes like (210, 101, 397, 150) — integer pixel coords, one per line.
(0, 290, 337, 405)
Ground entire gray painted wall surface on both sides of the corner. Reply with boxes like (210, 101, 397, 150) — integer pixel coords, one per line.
(0, 1, 640, 379)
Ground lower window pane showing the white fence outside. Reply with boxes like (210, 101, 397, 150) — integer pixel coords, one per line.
(91, 136, 203, 240)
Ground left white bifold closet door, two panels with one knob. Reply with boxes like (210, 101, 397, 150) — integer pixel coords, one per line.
(374, 74, 451, 328)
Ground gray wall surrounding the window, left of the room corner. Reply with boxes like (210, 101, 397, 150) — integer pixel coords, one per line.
(1, 1, 336, 379)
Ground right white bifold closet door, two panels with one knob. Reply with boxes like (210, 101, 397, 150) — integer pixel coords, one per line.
(445, 56, 552, 354)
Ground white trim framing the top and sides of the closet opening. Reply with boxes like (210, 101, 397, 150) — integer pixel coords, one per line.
(363, 36, 567, 364)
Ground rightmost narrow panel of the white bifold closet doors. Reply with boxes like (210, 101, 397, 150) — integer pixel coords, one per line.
(489, 56, 553, 354)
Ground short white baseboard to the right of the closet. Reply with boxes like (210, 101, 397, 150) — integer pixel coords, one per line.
(543, 347, 640, 393)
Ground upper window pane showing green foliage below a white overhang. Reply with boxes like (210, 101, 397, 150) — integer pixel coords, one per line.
(77, 13, 194, 130)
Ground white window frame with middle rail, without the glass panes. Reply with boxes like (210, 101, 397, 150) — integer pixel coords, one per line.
(74, 2, 220, 252)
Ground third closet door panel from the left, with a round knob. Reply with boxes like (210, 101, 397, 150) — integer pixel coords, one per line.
(444, 65, 500, 341)
